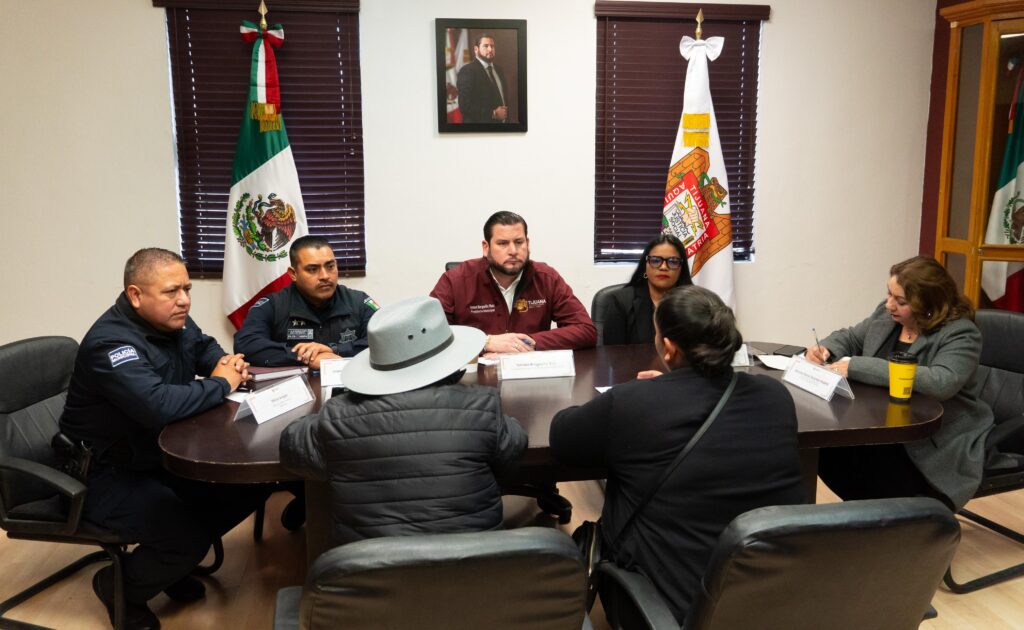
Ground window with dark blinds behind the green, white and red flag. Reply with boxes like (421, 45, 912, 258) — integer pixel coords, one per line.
(154, 0, 366, 278)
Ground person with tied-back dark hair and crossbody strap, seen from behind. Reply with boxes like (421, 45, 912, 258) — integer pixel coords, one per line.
(550, 285, 805, 627)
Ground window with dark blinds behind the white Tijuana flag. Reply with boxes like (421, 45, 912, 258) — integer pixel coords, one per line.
(594, 1, 771, 262)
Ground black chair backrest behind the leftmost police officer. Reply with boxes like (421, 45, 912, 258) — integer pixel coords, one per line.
(0, 337, 78, 508)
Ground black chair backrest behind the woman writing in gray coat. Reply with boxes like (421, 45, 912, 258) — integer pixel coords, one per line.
(975, 309, 1024, 454)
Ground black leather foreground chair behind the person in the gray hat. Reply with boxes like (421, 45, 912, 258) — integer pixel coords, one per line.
(273, 528, 591, 630)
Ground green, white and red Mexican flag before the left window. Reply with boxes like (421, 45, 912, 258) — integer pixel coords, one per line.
(223, 20, 309, 328)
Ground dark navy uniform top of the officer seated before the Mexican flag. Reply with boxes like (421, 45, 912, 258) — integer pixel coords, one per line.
(234, 284, 377, 367)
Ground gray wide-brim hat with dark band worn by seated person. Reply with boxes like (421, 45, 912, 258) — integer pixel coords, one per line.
(342, 297, 486, 395)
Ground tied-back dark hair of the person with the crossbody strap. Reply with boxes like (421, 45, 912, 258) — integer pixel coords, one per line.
(654, 285, 743, 376)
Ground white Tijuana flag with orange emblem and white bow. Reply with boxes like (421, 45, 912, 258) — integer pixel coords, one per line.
(662, 36, 736, 309)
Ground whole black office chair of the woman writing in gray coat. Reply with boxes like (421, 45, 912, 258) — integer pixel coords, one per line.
(944, 309, 1024, 593)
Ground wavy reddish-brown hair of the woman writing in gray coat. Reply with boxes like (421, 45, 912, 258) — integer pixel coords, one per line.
(889, 256, 974, 333)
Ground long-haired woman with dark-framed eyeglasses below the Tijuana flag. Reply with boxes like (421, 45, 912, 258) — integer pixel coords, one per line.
(604, 233, 693, 345)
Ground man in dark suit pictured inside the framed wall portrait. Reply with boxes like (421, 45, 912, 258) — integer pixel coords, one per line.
(457, 33, 509, 123)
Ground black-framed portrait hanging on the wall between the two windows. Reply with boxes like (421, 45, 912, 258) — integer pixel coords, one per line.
(434, 17, 526, 133)
